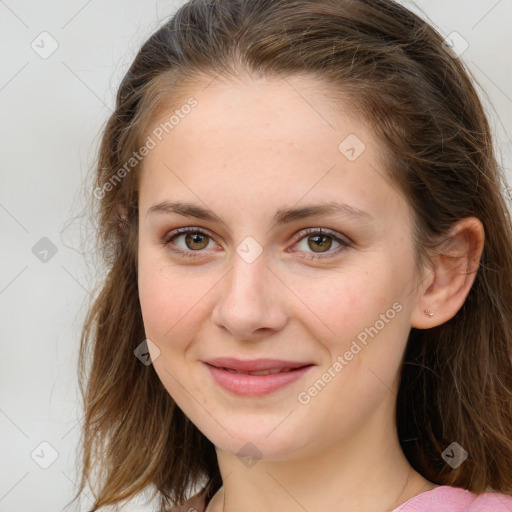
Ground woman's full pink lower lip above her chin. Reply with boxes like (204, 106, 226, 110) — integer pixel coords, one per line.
(205, 363, 313, 396)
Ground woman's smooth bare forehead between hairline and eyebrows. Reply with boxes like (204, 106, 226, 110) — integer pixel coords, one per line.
(140, 77, 406, 226)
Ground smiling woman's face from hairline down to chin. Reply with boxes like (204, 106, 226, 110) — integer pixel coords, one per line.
(138, 78, 426, 459)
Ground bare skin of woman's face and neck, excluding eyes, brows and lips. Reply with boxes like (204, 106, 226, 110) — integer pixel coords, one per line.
(138, 79, 432, 512)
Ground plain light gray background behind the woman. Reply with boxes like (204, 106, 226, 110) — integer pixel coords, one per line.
(0, 0, 512, 512)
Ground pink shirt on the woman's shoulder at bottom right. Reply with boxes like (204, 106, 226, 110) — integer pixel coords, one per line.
(391, 485, 512, 512)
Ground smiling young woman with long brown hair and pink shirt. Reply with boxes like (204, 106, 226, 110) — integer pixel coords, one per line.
(74, 0, 512, 512)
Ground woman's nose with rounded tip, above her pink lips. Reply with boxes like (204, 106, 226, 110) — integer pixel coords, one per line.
(212, 254, 289, 340)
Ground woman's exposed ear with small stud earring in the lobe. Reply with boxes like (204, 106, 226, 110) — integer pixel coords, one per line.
(411, 217, 485, 329)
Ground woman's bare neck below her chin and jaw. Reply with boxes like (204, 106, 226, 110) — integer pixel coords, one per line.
(207, 392, 435, 512)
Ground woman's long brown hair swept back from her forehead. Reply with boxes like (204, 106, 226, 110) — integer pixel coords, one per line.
(75, 0, 512, 510)
